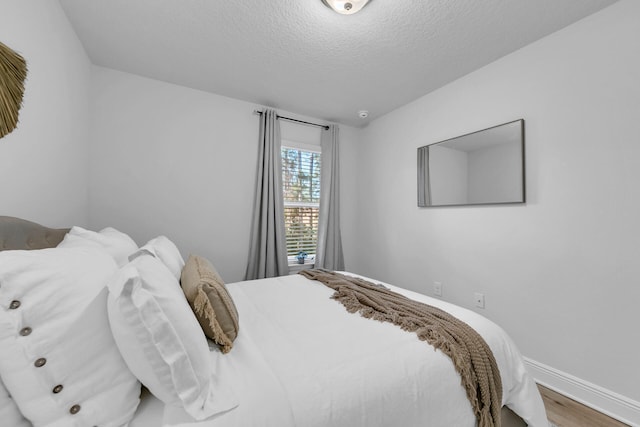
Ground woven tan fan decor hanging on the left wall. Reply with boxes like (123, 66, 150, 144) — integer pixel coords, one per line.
(0, 42, 27, 138)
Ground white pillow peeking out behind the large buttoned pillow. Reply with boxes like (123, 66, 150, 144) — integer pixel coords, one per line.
(58, 226, 138, 267)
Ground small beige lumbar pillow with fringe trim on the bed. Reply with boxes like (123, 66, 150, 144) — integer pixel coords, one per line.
(180, 255, 239, 353)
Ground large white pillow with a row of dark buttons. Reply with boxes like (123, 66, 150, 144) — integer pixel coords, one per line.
(0, 248, 140, 427)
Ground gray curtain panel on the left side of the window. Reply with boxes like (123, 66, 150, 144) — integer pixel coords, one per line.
(245, 109, 289, 280)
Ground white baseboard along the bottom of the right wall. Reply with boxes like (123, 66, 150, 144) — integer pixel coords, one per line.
(524, 357, 640, 427)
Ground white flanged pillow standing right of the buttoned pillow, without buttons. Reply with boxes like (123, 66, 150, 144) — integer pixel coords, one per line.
(108, 255, 237, 420)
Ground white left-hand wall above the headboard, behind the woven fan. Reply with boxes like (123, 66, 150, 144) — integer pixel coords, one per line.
(0, 0, 90, 227)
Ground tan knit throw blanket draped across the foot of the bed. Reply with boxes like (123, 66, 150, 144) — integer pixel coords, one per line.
(300, 270, 502, 427)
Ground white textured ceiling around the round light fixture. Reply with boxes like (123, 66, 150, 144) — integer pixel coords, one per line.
(60, 0, 615, 126)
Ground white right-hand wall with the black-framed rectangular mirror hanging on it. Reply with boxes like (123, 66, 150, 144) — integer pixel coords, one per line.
(349, 0, 640, 412)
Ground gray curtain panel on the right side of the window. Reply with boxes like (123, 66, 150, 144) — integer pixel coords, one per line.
(315, 125, 344, 270)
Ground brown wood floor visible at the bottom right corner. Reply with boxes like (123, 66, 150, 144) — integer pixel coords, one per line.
(538, 385, 628, 427)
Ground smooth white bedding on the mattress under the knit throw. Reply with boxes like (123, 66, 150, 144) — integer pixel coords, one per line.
(130, 275, 548, 427)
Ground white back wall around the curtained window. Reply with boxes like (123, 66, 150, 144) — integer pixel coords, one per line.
(90, 67, 355, 282)
